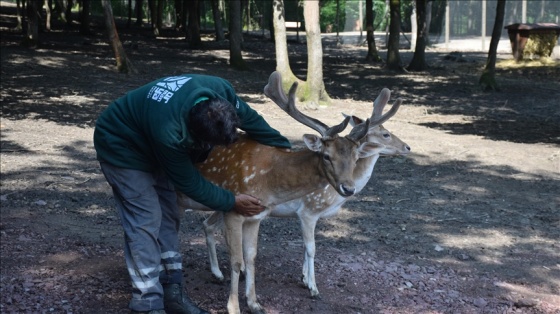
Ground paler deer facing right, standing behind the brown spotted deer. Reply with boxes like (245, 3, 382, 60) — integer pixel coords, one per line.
(199, 84, 411, 298)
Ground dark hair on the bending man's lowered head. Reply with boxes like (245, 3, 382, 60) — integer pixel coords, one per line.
(188, 98, 240, 145)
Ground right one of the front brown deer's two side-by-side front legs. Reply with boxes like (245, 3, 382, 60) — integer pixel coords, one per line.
(243, 220, 265, 314)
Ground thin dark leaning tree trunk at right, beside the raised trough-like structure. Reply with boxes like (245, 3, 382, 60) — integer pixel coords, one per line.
(478, 0, 506, 90)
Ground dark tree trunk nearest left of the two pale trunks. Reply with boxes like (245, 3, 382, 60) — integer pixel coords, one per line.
(229, 0, 249, 70)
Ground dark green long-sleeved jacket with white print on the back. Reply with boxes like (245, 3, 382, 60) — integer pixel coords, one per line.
(93, 74, 290, 211)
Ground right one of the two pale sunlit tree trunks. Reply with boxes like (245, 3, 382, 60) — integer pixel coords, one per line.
(301, 1, 331, 108)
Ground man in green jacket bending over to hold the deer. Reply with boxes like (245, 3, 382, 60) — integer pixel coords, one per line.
(94, 74, 290, 313)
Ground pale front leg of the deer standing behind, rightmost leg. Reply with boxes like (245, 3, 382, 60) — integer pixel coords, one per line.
(299, 213, 320, 298)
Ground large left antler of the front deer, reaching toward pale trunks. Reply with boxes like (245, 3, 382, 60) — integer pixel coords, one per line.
(264, 71, 350, 137)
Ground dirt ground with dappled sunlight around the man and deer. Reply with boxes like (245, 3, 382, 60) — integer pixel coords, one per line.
(0, 3, 560, 313)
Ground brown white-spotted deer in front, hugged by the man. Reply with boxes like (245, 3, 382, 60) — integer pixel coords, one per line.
(177, 72, 385, 314)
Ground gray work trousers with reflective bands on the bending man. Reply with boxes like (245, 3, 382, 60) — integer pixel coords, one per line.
(100, 162, 182, 311)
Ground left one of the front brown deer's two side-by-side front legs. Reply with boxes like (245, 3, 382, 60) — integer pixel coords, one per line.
(224, 212, 243, 314)
